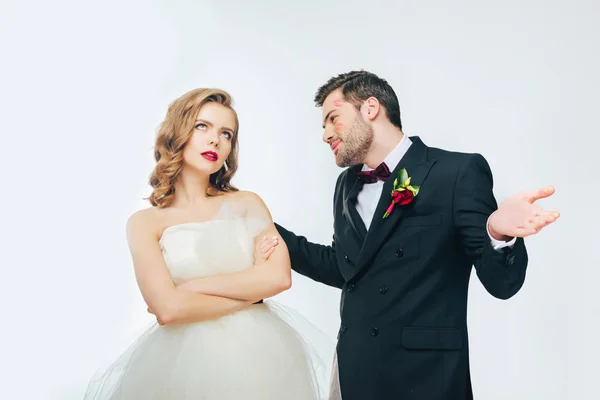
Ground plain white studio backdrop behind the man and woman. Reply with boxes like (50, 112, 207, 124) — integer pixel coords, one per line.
(0, 0, 600, 400)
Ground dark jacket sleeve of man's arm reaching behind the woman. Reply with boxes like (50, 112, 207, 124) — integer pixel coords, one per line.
(275, 224, 345, 288)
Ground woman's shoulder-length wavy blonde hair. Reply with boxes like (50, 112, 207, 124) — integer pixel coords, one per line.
(148, 89, 240, 207)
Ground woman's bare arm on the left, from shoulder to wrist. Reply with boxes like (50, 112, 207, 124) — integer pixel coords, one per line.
(127, 211, 252, 325)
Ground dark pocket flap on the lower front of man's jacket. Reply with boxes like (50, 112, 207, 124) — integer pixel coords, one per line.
(402, 326, 463, 350)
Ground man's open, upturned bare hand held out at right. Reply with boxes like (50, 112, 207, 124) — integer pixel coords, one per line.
(488, 186, 560, 241)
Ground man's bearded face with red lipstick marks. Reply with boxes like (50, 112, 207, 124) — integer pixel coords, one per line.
(323, 89, 373, 167)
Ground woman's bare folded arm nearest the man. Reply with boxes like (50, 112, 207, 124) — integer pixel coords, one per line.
(178, 192, 292, 302)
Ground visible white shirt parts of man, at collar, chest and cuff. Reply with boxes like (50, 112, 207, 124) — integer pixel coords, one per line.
(356, 135, 517, 250)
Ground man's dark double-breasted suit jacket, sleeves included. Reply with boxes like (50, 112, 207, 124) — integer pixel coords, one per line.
(276, 137, 527, 400)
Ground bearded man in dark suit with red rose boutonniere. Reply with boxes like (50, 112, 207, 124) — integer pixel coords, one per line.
(276, 71, 558, 400)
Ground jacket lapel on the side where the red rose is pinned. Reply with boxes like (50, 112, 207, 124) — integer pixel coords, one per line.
(352, 136, 435, 276)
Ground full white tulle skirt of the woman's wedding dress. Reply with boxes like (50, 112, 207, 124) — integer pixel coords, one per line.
(84, 301, 335, 400)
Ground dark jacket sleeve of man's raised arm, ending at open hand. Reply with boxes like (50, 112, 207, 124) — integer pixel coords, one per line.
(453, 154, 528, 299)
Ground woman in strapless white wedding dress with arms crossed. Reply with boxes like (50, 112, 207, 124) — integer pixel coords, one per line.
(85, 89, 334, 400)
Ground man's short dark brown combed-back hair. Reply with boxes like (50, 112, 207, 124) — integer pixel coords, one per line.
(314, 70, 402, 129)
